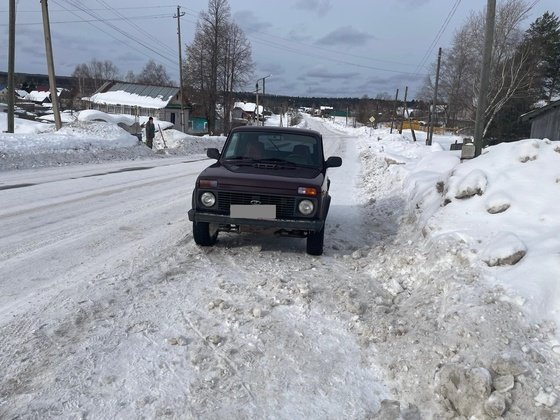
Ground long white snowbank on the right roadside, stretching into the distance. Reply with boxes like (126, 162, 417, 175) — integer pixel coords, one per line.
(333, 116, 560, 340)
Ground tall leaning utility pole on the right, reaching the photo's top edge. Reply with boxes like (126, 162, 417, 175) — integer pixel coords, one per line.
(474, 0, 496, 157)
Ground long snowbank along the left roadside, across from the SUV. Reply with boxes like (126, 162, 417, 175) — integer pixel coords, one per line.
(0, 110, 225, 170)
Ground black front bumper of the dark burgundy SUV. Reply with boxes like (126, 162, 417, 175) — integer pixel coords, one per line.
(188, 209, 325, 232)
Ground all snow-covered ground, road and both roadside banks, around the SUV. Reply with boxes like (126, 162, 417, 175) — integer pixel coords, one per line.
(0, 110, 560, 419)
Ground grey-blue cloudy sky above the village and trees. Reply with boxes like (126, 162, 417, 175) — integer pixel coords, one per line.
(0, 0, 559, 98)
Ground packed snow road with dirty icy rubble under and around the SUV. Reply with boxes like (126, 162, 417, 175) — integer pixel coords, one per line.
(0, 120, 558, 419)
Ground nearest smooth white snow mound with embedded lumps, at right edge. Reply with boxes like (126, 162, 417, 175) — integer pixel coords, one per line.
(424, 139, 560, 323)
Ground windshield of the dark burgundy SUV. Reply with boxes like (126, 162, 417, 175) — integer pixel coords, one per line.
(222, 131, 322, 167)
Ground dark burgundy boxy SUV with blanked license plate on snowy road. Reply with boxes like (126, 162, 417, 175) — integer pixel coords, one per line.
(188, 126, 342, 255)
